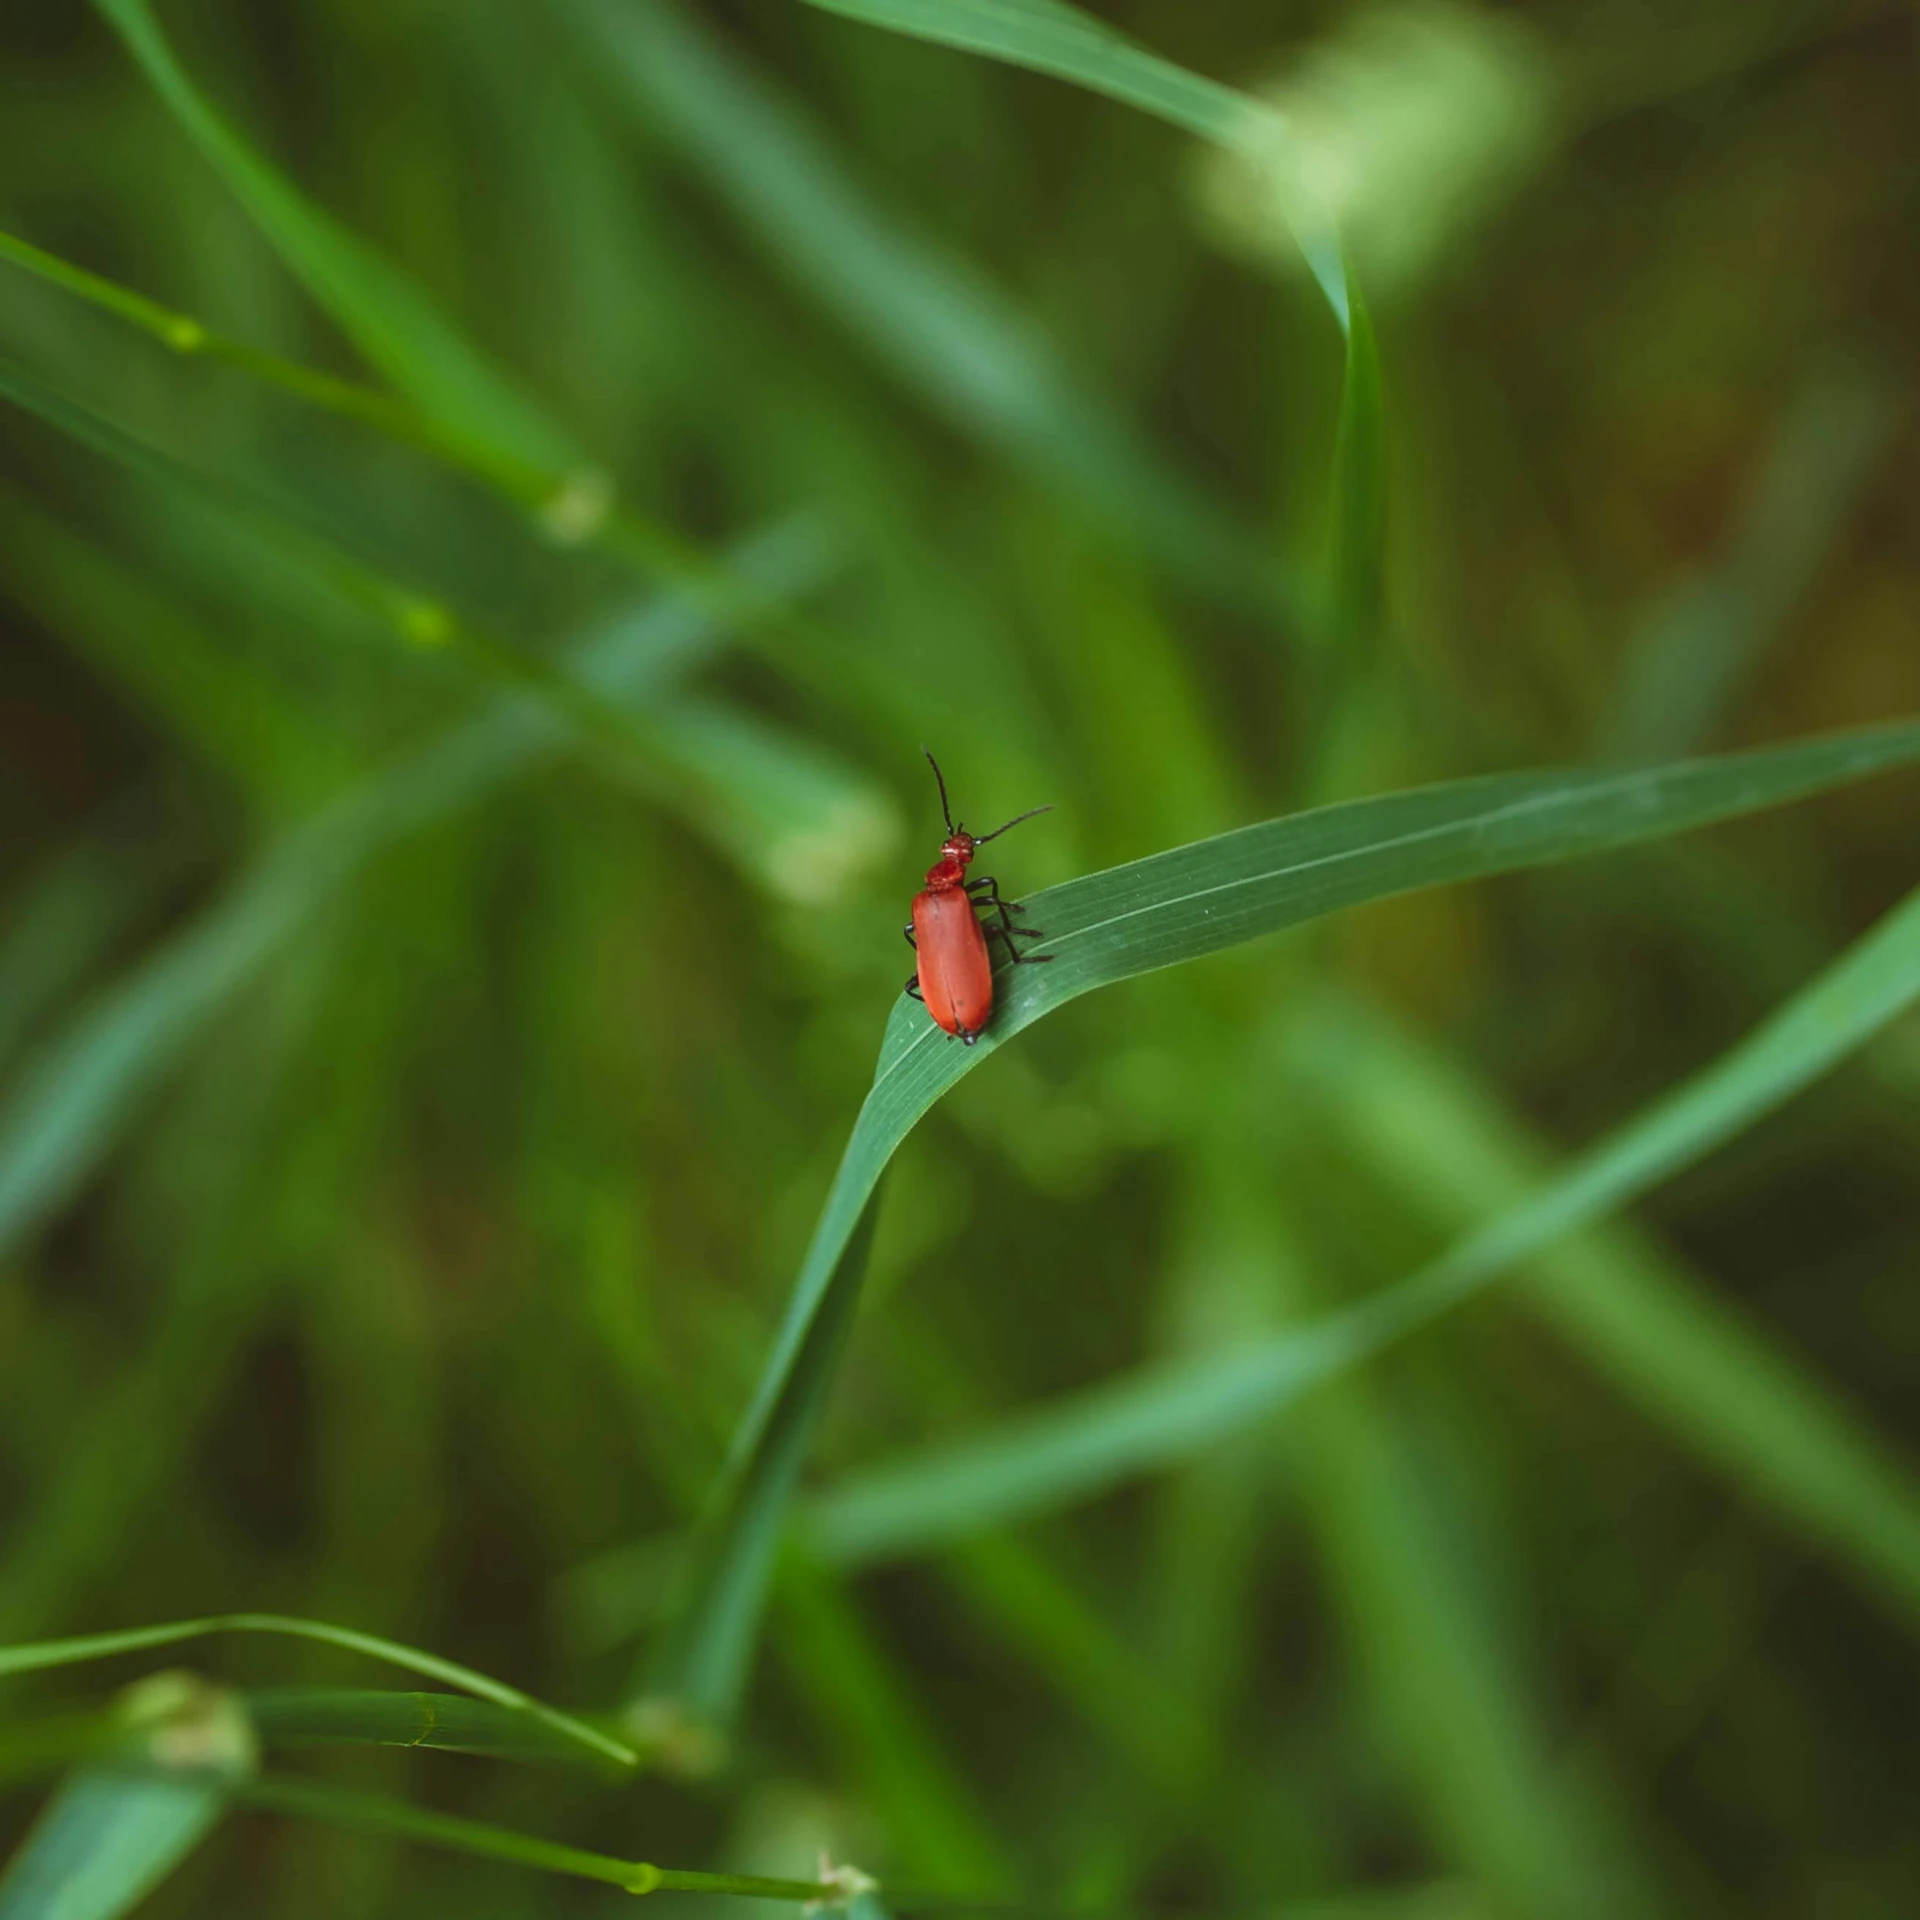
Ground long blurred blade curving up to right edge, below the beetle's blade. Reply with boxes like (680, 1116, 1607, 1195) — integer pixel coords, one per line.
(808, 871, 1920, 1561)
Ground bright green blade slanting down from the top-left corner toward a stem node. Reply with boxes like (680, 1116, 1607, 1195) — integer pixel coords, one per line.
(94, 0, 582, 468)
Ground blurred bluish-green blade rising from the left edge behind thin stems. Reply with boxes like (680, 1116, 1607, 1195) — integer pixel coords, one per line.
(0, 526, 828, 1250)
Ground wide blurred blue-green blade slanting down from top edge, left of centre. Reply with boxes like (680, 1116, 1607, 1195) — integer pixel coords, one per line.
(563, 0, 1308, 611)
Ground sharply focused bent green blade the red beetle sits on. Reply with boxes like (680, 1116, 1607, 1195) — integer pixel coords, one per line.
(655, 722, 1920, 1707)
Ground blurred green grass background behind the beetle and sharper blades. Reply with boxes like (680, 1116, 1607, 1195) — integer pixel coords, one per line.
(0, 0, 1920, 1920)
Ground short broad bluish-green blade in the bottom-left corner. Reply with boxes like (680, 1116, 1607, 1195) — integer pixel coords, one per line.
(0, 1770, 227, 1920)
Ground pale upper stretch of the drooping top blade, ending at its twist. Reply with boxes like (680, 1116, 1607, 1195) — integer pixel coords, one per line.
(787, 0, 1348, 314)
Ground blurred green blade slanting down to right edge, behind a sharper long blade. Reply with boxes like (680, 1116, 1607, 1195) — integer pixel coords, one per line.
(1290, 998, 1920, 1617)
